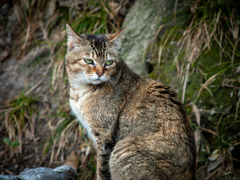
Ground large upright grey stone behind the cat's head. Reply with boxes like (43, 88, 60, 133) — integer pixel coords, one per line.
(121, 0, 176, 74)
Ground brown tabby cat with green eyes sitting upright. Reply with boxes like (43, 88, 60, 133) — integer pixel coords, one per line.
(65, 25, 196, 180)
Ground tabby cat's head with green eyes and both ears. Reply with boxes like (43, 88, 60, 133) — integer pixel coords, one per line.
(65, 25, 122, 84)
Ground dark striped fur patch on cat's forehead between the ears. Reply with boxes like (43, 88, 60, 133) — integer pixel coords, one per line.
(87, 34, 108, 57)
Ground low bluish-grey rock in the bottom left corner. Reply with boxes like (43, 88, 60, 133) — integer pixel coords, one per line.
(0, 165, 77, 180)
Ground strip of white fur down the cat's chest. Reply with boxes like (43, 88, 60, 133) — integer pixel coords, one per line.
(69, 88, 97, 146)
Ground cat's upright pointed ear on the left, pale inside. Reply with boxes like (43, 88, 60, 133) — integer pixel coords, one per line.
(66, 24, 84, 51)
